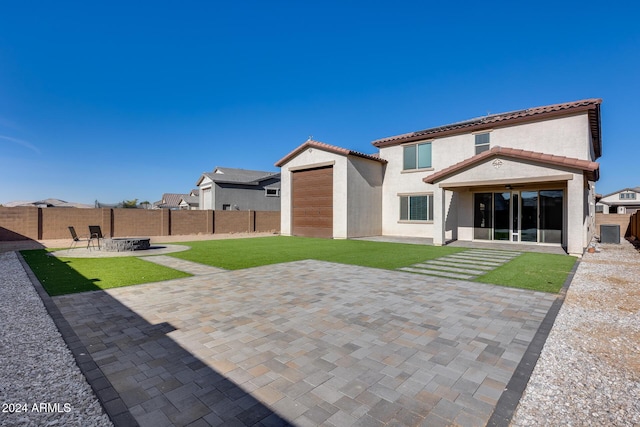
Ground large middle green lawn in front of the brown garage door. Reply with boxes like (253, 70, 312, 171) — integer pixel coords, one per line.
(165, 236, 463, 270)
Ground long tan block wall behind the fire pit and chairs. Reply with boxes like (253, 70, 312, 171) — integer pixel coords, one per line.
(0, 207, 280, 241)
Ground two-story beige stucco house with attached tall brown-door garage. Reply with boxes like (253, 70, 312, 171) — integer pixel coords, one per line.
(276, 99, 602, 254)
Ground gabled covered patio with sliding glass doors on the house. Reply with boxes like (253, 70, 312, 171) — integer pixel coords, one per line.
(423, 147, 599, 254)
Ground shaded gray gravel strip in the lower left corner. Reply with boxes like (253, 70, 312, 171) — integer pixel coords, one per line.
(0, 252, 112, 427)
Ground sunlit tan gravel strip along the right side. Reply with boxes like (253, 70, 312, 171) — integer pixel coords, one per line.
(511, 240, 640, 426)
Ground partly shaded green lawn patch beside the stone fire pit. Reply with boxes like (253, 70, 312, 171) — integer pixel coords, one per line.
(20, 249, 191, 296)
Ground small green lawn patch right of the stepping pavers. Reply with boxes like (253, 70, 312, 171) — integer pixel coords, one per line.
(475, 252, 577, 293)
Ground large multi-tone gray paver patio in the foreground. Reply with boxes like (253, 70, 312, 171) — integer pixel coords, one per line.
(54, 260, 556, 427)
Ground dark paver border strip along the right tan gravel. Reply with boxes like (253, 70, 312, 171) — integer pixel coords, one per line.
(486, 259, 581, 427)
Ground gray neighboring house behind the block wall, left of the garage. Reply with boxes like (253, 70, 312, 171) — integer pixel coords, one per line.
(196, 167, 280, 211)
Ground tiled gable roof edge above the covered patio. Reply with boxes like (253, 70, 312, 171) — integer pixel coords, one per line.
(423, 147, 600, 184)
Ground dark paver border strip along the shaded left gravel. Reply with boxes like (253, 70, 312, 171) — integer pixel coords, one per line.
(15, 251, 139, 427)
